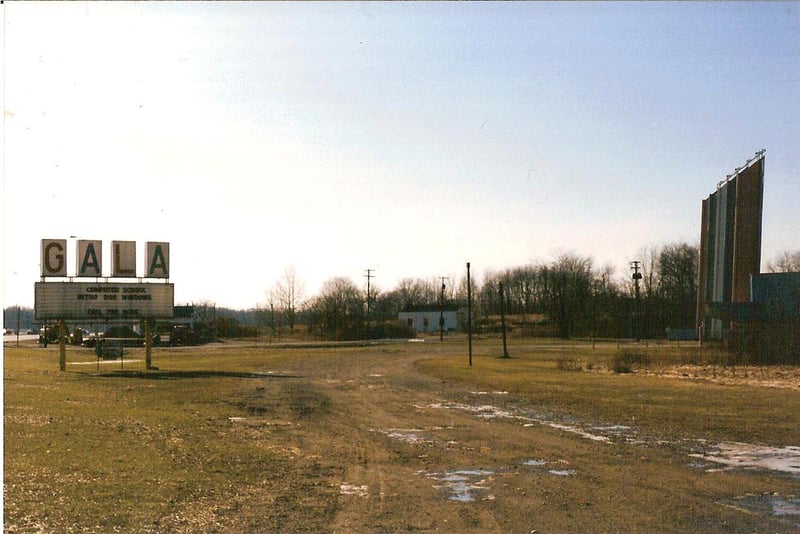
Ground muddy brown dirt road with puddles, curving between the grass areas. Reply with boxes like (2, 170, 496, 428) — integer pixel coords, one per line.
(189, 345, 800, 533)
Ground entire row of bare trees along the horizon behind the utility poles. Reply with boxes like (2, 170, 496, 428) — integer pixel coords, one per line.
(266, 247, 800, 339)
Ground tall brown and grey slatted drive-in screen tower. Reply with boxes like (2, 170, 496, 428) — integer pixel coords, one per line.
(697, 150, 764, 340)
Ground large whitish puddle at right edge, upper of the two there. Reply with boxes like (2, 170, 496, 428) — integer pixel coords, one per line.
(689, 442, 800, 476)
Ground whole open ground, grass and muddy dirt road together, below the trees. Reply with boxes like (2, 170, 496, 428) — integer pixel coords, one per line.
(3, 338, 800, 533)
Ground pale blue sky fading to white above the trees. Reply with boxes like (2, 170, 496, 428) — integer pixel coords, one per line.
(0, 2, 800, 308)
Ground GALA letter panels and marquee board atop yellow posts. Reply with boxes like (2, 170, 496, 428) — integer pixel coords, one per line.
(34, 239, 175, 320)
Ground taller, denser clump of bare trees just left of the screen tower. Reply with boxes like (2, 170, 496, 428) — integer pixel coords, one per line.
(478, 243, 698, 339)
